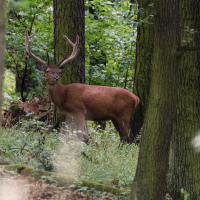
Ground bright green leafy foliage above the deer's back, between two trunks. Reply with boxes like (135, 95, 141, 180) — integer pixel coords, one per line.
(85, 0, 136, 89)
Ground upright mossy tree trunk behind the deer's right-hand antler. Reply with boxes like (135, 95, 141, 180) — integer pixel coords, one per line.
(54, 0, 85, 122)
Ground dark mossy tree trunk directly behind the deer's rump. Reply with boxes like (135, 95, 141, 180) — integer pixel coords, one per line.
(130, 0, 154, 141)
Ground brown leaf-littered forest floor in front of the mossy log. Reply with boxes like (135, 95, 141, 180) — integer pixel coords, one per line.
(0, 171, 128, 200)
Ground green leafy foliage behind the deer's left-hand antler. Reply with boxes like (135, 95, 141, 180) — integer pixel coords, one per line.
(6, 0, 53, 101)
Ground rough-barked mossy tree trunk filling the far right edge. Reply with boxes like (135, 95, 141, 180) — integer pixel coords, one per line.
(168, 0, 200, 200)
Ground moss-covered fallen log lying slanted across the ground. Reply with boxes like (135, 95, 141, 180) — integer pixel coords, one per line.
(0, 165, 128, 195)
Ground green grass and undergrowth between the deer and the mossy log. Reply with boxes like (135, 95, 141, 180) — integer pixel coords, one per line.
(0, 119, 139, 189)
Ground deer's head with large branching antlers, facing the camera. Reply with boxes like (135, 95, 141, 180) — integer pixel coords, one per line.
(25, 29, 79, 85)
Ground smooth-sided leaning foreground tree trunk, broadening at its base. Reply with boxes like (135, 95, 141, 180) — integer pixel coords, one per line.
(131, 0, 180, 200)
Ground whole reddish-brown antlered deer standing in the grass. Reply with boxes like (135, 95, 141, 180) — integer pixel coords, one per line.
(25, 30, 140, 144)
